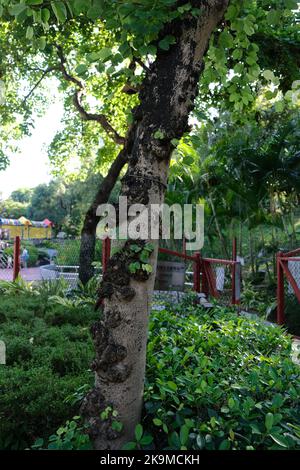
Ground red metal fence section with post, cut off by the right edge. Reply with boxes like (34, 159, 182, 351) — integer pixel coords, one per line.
(277, 248, 300, 325)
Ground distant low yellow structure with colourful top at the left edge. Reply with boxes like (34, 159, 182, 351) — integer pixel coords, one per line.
(0, 216, 53, 240)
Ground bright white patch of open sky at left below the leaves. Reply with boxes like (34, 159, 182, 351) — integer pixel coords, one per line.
(0, 100, 63, 198)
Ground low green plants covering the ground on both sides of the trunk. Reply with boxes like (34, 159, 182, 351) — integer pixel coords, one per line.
(0, 290, 300, 450)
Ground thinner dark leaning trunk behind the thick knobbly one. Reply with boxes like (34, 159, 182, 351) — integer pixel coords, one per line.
(79, 150, 130, 284)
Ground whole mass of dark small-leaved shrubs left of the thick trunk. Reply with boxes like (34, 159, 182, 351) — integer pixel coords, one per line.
(0, 291, 98, 449)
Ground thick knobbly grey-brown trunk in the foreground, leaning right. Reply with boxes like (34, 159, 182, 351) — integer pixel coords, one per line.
(82, 0, 228, 449)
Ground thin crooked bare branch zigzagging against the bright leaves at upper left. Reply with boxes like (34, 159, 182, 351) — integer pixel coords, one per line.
(56, 46, 126, 145)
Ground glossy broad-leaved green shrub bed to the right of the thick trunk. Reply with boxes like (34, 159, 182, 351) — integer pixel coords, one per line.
(141, 307, 300, 450)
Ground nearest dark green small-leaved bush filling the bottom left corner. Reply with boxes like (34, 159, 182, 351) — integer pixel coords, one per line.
(0, 366, 91, 449)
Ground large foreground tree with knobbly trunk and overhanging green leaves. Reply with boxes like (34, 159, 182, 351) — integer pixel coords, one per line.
(1, 0, 297, 449)
